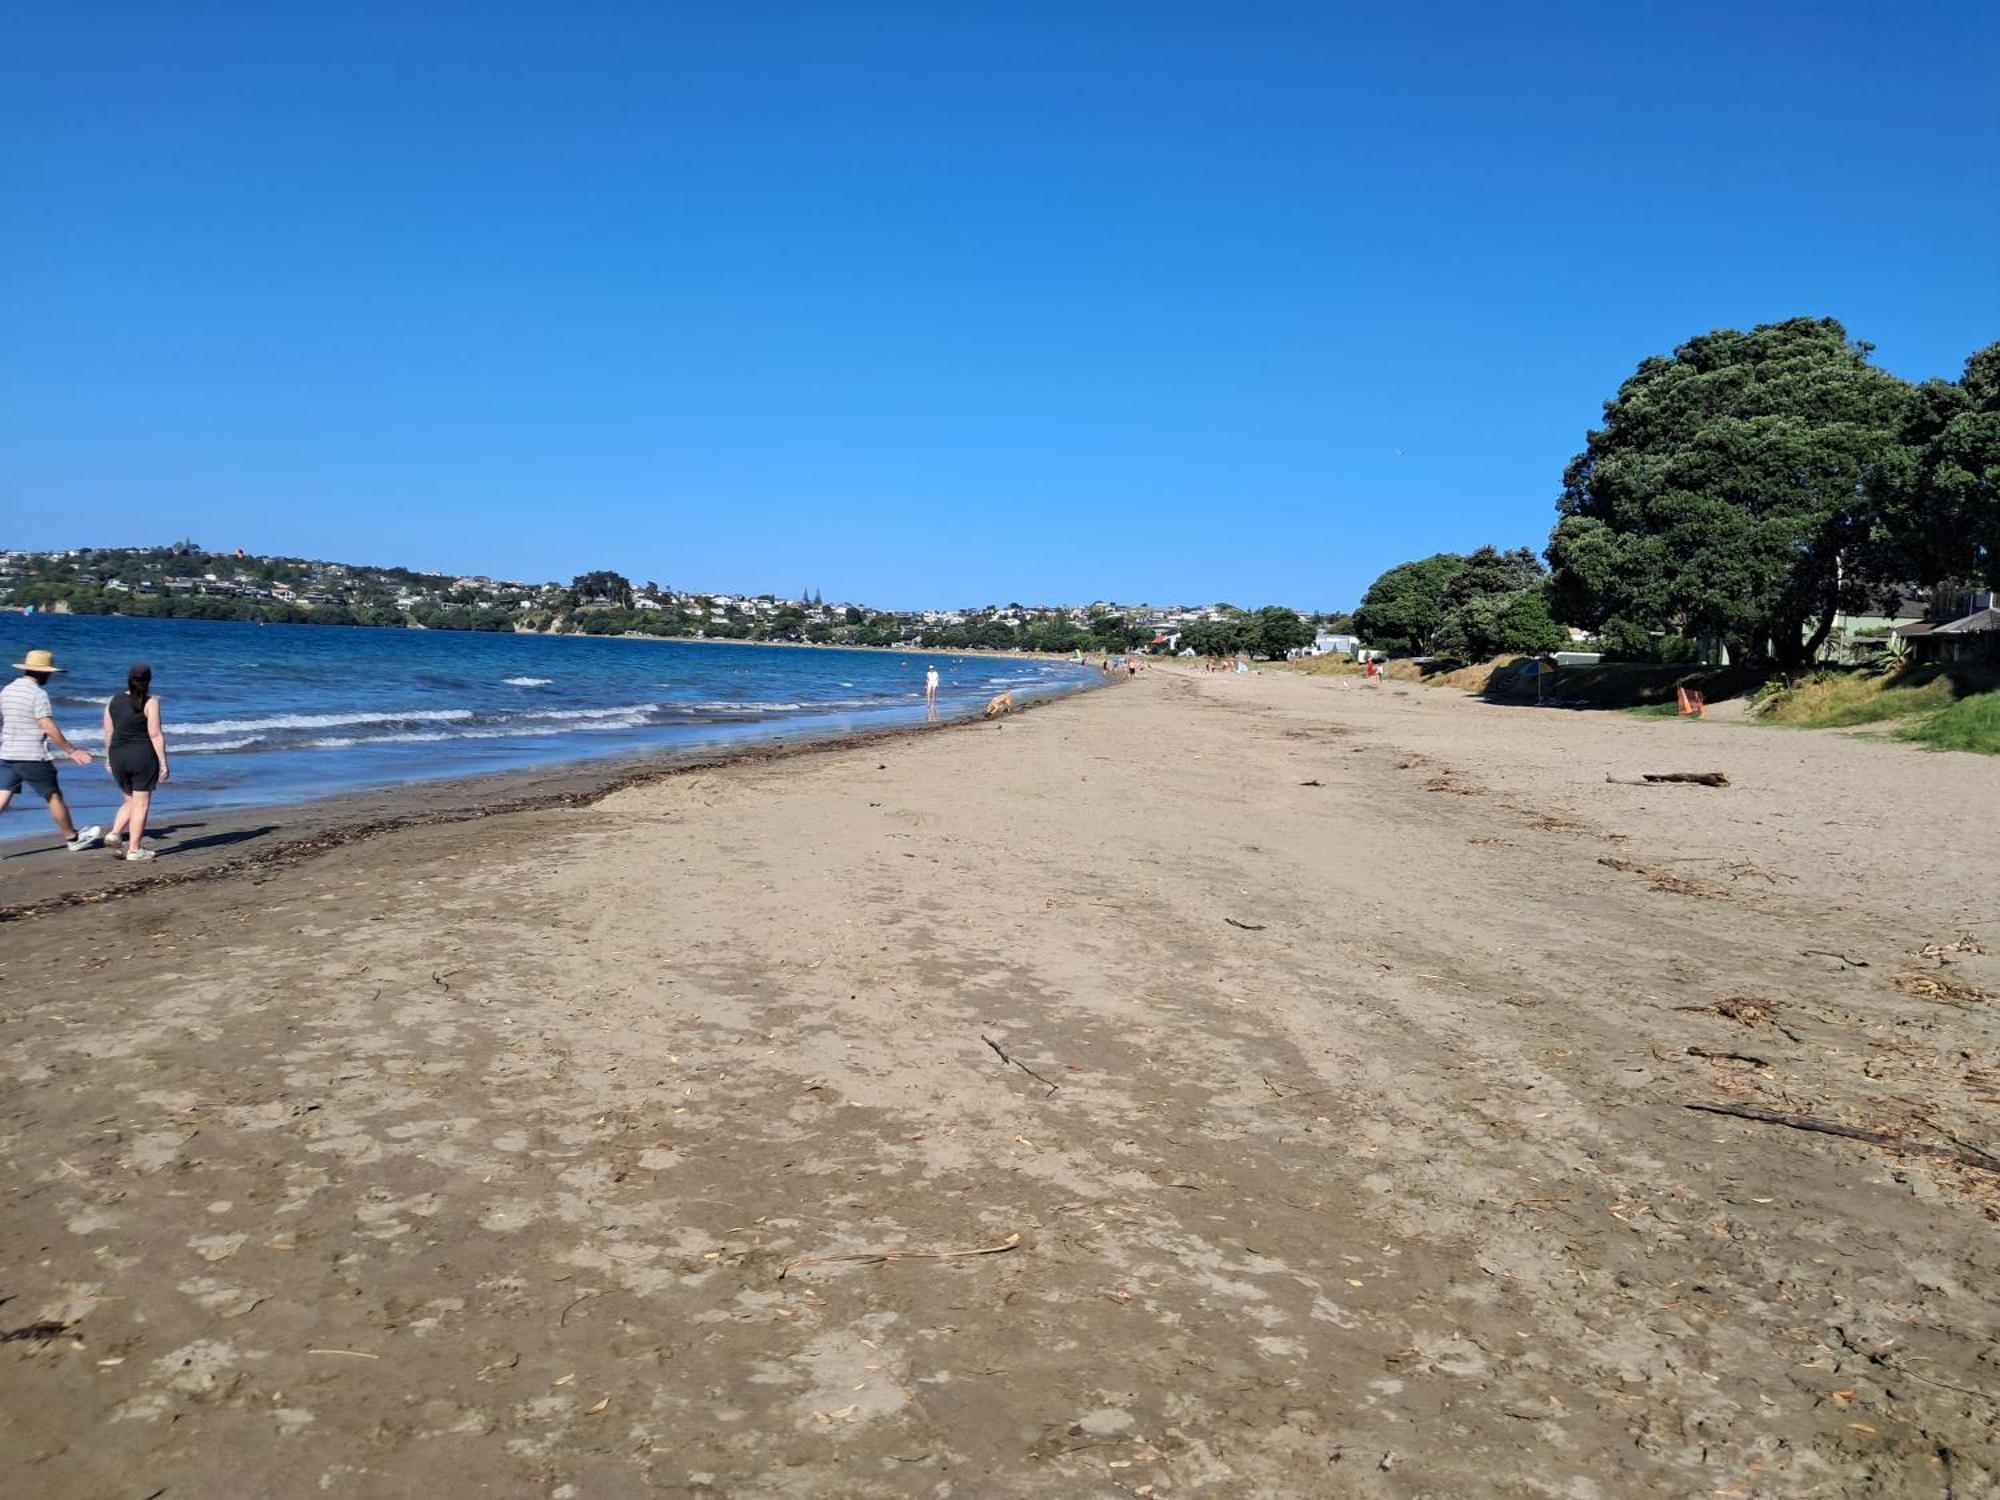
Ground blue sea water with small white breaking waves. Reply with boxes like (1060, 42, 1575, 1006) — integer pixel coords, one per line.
(0, 614, 1098, 824)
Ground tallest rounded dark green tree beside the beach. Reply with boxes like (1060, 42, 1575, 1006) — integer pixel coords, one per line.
(1548, 318, 1914, 666)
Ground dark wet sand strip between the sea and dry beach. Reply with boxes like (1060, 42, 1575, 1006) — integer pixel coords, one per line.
(0, 684, 1112, 926)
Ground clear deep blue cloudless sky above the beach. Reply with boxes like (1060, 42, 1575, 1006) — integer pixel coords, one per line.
(0, 0, 2000, 606)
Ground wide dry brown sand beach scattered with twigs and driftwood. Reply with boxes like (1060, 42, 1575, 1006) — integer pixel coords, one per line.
(0, 672, 2000, 1500)
